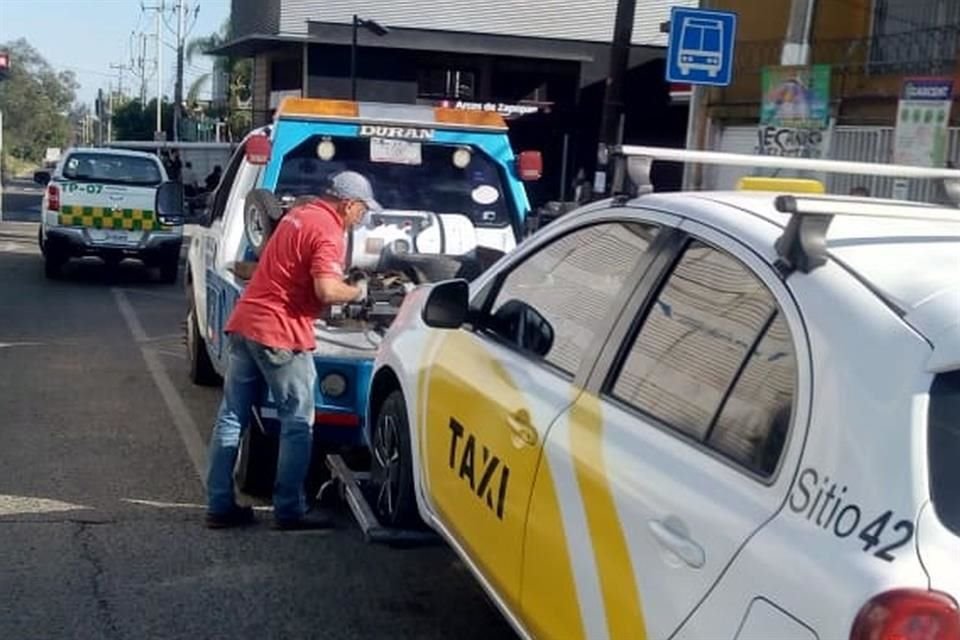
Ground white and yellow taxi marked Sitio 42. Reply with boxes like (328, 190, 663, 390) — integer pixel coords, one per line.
(369, 151, 960, 640)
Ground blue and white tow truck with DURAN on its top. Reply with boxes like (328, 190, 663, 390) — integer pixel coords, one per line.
(185, 98, 542, 495)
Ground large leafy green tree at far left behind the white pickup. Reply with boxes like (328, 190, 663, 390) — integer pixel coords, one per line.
(0, 38, 80, 162)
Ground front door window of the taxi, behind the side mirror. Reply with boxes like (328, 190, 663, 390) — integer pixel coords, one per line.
(483, 222, 657, 376)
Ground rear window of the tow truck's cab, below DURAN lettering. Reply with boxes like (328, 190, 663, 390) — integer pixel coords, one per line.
(274, 135, 515, 227)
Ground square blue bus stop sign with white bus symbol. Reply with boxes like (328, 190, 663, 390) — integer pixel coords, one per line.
(667, 7, 737, 87)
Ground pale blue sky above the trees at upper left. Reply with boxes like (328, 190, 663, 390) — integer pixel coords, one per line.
(0, 0, 230, 105)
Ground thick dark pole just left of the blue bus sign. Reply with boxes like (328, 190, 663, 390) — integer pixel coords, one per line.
(593, 0, 637, 195)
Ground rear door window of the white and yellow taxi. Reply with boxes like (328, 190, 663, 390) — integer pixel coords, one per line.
(610, 243, 796, 477)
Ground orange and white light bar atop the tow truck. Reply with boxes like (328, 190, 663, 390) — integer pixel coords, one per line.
(276, 97, 507, 129)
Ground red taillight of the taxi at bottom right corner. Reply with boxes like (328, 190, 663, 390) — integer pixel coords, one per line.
(850, 589, 960, 640)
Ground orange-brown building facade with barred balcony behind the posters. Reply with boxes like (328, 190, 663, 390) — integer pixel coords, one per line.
(703, 0, 960, 199)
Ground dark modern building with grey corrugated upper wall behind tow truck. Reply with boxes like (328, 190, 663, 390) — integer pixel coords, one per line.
(215, 0, 697, 203)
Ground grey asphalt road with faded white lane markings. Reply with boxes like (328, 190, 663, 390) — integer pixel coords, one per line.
(0, 180, 515, 640)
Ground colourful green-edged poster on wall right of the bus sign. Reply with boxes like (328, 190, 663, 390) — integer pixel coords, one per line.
(756, 64, 830, 158)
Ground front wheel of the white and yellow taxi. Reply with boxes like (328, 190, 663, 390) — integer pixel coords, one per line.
(370, 390, 422, 528)
